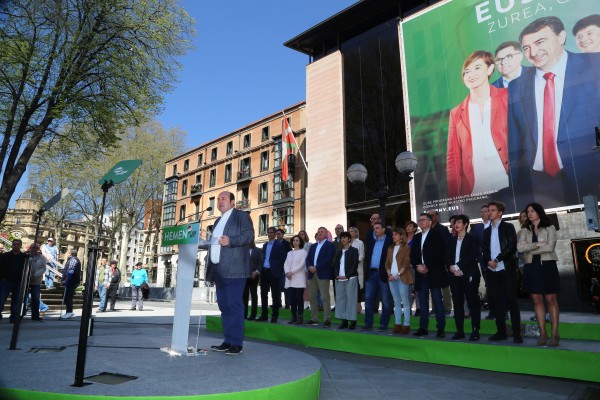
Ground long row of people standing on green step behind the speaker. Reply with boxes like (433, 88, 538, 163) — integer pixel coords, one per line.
(245, 201, 560, 346)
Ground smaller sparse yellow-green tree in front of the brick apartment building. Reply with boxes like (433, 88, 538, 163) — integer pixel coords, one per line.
(29, 121, 186, 278)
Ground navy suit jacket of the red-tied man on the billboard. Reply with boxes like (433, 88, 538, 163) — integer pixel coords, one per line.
(506, 52, 600, 213)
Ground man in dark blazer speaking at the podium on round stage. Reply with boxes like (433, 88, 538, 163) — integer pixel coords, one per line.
(208, 192, 254, 355)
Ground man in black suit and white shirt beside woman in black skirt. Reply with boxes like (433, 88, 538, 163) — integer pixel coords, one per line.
(483, 201, 523, 343)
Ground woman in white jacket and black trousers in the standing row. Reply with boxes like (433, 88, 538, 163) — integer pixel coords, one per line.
(283, 235, 308, 325)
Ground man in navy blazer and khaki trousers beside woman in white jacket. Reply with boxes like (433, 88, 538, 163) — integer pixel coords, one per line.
(304, 227, 335, 328)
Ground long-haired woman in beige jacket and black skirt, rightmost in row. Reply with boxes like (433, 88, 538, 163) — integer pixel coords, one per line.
(517, 203, 560, 347)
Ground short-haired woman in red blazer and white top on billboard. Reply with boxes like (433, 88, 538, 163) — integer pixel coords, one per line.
(446, 50, 508, 198)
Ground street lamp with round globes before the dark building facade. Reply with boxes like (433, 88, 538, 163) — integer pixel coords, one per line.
(346, 151, 419, 226)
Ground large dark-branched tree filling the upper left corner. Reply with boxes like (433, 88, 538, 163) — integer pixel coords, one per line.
(0, 0, 195, 221)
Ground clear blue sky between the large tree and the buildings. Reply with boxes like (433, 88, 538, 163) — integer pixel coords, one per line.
(9, 0, 357, 208)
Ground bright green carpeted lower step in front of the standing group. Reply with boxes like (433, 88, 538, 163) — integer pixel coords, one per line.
(206, 316, 600, 382)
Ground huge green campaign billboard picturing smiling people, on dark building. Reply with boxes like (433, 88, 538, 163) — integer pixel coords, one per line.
(400, 0, 600, 217)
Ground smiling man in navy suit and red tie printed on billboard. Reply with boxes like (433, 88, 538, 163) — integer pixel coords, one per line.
(508, 17, 600, 212)
